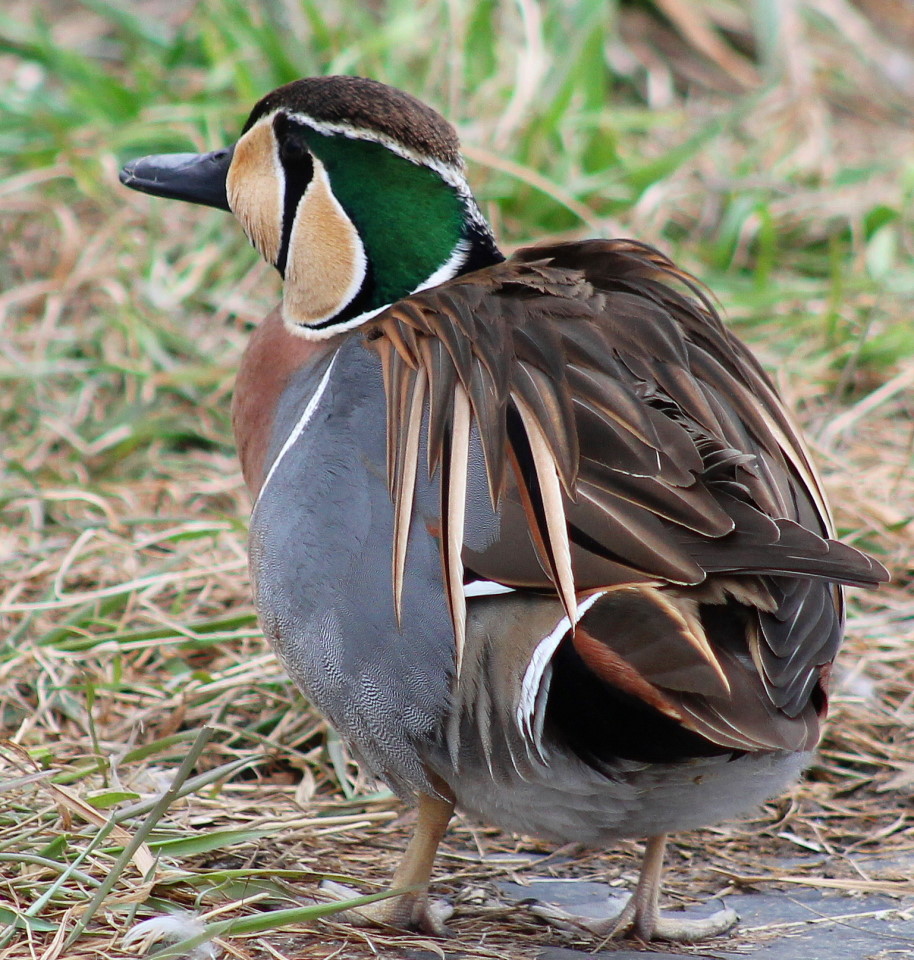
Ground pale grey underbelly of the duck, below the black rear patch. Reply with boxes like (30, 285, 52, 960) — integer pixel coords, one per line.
(442, 751, 812, 846)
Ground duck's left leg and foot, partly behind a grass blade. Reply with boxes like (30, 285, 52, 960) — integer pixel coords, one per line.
(321, 788, 454, 936)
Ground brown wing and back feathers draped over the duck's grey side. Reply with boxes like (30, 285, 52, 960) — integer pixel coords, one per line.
(367, 240, 886, 749)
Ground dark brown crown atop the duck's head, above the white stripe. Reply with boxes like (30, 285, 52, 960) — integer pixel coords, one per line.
(242, 77, 462, 166)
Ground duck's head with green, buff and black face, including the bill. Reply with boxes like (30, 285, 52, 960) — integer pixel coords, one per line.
(121, 77, 502, 339)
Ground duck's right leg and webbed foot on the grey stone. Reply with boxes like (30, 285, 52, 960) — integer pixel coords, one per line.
(607, 833, 739, 943)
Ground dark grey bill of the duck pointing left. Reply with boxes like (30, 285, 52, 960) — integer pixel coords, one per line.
(121, 147, 235, 212)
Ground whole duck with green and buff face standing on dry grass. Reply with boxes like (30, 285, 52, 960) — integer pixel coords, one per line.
(121, 76, 887, 942)
